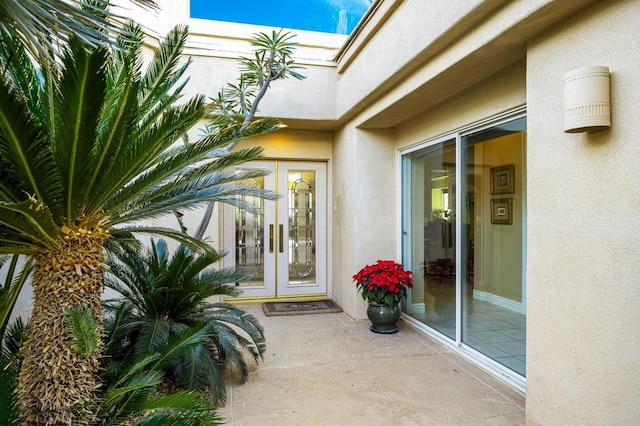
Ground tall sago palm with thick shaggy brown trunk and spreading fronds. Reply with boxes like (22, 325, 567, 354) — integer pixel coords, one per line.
(0, 25, 276, 424)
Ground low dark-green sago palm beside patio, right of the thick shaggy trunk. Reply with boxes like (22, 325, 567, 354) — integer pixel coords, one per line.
(105, 240, 266, 404)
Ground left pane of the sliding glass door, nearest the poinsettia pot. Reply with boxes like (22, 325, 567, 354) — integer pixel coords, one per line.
(403, 139, 457, 339)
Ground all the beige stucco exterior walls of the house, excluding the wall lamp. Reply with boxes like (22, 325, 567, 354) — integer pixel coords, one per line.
(117, 0, 640, 425)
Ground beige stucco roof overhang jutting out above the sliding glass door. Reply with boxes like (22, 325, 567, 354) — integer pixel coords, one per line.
(337, 0, 594, 128)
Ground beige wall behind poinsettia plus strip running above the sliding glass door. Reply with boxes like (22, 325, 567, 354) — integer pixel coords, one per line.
(331, 66, 525, 318)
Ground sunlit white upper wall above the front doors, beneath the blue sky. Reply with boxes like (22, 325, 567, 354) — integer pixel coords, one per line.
(114, 0, 346, 129)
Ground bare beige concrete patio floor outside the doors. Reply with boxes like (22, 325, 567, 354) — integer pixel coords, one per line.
(220, 306, 525, 426)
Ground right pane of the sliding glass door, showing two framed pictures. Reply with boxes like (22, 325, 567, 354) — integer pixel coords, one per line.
(462, 118, 526, 376)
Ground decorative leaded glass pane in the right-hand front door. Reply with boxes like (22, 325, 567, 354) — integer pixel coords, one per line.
(287, 170, 316, 285)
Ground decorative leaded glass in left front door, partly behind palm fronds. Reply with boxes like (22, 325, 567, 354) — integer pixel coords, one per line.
(235, 178, 264, 287)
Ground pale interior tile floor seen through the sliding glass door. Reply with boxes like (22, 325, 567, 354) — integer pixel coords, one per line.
(411, 279, 526, 376)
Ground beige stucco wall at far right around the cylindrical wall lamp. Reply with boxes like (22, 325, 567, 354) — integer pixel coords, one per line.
(527, 0, 640, 425)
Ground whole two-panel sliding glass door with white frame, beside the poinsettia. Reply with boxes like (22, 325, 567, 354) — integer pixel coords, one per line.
(402, 115, 526, 377)
